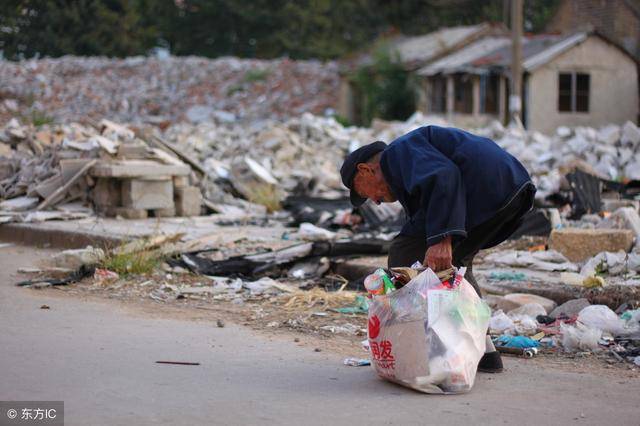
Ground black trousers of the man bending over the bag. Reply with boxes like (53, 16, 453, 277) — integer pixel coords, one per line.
(388, 184, 535, 296)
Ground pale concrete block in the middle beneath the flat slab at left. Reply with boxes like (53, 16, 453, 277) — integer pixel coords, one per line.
(122, 179, 174, 210)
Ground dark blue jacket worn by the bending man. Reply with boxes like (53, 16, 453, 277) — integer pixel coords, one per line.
(380, 126, 531, 246)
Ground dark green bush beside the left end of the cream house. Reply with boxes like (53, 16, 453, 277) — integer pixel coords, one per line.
(352, 43, 416, 125)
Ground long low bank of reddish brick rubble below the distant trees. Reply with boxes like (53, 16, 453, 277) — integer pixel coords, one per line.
(0, 56, 339, 126)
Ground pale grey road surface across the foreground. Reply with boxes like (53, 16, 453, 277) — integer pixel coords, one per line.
(0, 246, 640, 426)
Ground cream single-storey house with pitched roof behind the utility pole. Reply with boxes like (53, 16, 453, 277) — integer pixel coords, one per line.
(417, 32, 638, 133)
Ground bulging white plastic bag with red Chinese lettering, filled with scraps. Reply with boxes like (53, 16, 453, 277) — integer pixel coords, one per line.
(369, 268, 491, 394)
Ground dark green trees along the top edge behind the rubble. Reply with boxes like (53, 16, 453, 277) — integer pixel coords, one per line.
(0, 0, 559, 59)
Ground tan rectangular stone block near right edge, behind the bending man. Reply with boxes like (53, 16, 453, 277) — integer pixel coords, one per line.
(549, 228, 634, 262)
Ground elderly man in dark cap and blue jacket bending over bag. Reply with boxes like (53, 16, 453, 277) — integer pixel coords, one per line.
(340, 126, 535, 372)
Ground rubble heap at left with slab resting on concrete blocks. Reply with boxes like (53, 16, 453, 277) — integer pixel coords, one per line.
(0, 119, 202, 223)
